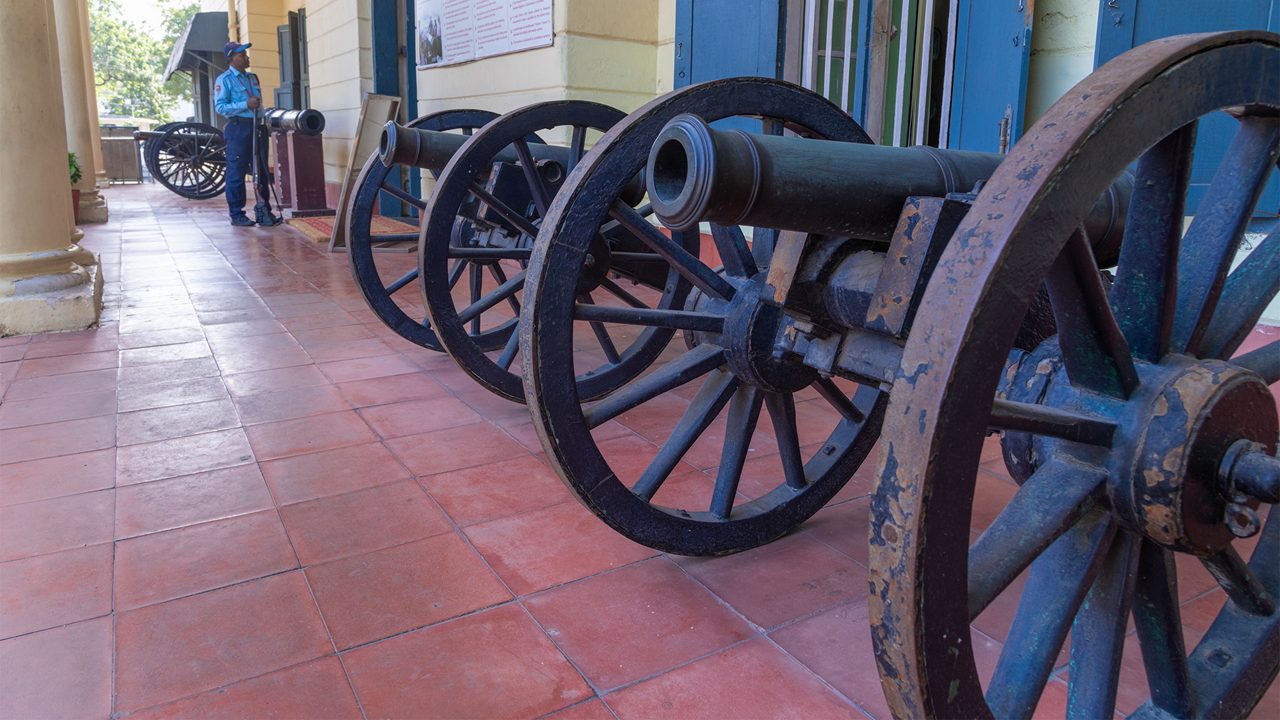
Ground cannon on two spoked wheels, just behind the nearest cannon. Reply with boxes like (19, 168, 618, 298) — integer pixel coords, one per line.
(351, 101, 696, 401)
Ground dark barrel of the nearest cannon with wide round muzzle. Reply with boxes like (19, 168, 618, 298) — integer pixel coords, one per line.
(646, 114, 1132, 256)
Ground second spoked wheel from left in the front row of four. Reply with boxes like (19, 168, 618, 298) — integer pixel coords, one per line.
(419, 100, 687, 402)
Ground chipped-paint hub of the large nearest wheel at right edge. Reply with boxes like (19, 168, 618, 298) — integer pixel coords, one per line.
(1110, 359, 1277, 555)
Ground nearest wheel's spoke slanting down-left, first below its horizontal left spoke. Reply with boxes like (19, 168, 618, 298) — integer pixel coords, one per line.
(969, 460, 1107, 618)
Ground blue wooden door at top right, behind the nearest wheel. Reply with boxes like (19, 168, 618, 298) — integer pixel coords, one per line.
(1094, 0, 1280, 217)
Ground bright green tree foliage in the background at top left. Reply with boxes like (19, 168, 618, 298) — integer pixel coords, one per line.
(88, 0, 200, 120)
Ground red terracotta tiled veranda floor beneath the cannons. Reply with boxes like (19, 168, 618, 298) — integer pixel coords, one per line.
(0, 180, 1280, 720)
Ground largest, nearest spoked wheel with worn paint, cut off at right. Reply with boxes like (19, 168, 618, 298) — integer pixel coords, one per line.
(870, 32, 1280, 717)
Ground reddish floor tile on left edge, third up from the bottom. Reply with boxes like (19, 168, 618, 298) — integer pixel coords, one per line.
(0, 489, 114, 561)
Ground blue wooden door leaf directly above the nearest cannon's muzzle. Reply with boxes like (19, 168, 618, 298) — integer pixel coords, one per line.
(675, 0, 785, 87)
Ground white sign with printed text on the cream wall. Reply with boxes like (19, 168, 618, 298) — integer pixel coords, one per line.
(415, 0, 554, 68)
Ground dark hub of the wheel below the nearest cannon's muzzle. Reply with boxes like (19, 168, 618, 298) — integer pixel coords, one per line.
(721, 279, 818, 392)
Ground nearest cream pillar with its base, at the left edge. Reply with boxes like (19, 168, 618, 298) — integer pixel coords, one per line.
(0, 0, 102, 336)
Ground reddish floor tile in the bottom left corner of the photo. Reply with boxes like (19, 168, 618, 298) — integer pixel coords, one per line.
(0, 609, 111, 719)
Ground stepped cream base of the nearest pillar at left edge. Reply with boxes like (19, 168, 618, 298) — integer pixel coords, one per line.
(0, 258, 102, 337)
